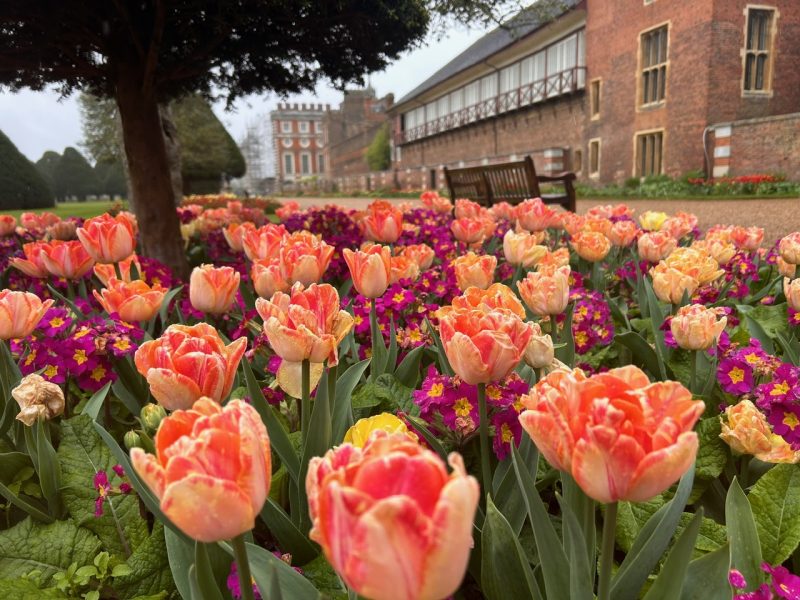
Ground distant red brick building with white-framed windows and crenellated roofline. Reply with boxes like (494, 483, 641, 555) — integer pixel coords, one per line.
(270, 103, 330, 189)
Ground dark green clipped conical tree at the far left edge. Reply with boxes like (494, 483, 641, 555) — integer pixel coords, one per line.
(0, 131, 54, 210)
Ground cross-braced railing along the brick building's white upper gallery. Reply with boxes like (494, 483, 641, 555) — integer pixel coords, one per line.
(395, 67, 586, 144)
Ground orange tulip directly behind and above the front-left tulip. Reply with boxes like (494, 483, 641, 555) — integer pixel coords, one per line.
(134, 323, 247, 410)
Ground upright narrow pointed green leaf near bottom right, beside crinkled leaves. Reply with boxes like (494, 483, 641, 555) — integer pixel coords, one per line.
(725, 479, 764, 591)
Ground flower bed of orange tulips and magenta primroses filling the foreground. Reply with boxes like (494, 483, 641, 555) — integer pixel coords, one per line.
(0, 198, 800, 600)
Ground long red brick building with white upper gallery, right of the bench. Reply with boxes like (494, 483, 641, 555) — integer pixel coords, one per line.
(390, 0, 800, 188)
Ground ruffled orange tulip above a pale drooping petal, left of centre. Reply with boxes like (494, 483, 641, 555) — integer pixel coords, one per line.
(256, 283, 353, 366)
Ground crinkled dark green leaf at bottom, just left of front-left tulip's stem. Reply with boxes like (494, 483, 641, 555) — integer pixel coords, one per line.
(114, 521, 175, 599)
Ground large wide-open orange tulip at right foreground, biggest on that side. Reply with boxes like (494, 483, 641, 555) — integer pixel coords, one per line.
(520, 365, 705, 503)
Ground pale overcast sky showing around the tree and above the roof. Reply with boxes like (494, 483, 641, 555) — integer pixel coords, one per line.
(0, 23, 485, 169)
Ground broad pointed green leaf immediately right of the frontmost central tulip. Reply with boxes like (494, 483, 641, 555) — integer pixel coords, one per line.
(481, 496, 536, 600)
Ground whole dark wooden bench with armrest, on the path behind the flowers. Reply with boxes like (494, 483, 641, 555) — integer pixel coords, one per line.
(444, 156, 575, 212)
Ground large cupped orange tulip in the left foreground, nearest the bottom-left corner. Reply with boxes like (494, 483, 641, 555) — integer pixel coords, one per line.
(131, 398, 272, 543)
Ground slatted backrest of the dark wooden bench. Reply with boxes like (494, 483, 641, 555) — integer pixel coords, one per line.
(445, 156, 541, 206)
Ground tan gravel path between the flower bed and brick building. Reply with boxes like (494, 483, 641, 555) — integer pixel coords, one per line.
(290, 197, 800, 243)
